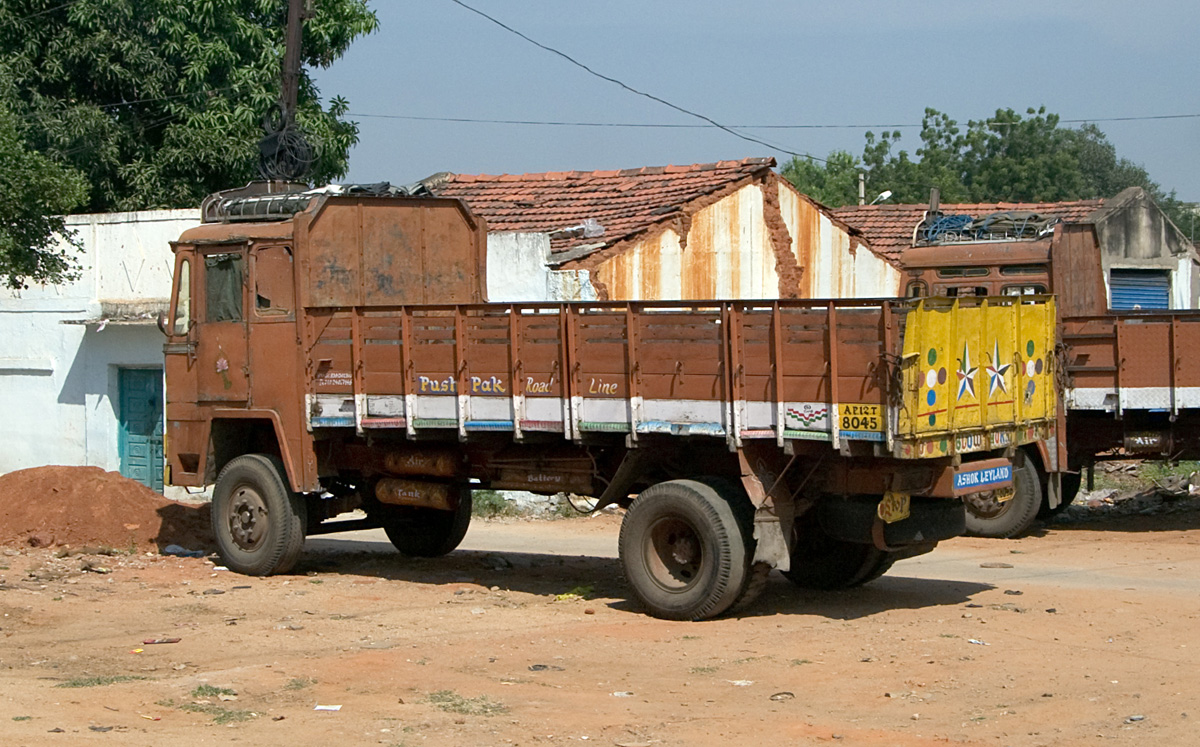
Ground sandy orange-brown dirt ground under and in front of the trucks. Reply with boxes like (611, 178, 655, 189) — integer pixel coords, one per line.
(0, 470, 1200, 747)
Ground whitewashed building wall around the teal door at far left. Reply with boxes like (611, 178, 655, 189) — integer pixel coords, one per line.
(0, 210, 199, 482)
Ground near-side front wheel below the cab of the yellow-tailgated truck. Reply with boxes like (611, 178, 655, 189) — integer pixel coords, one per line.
(212, 454, 307, 575)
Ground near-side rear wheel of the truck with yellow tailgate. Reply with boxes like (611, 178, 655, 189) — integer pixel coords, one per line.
(620, 480, 754, 620)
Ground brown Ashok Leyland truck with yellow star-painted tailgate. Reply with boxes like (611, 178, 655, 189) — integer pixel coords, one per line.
(161, 186, 1057, 620)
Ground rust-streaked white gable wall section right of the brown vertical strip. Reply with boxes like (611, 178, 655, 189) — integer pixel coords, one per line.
(778, 179, 900, 298)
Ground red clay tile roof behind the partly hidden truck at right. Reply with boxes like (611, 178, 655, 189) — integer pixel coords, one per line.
(832, 199, 1104, 262)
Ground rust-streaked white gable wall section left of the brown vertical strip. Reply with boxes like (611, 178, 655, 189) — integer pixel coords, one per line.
(593, 184, 779, 300)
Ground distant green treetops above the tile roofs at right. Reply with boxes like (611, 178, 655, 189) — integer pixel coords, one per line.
(782, 107, 1183, 225)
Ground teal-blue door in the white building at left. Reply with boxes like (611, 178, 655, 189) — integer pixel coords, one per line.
(118, 369, 163, 492)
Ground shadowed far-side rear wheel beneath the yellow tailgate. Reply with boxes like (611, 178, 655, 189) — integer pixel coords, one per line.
(784, 519, 900, 591)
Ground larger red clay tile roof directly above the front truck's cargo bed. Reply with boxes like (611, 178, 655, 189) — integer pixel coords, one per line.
(433, 159, 775, 253)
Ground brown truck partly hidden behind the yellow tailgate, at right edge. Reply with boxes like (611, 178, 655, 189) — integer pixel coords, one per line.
(901, 216, 1200, 537)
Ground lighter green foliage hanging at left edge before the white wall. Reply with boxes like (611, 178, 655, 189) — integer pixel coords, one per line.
(0, 103, 88, 288)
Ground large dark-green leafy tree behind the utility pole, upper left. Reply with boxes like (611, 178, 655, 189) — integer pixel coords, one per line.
(0, 0, 377, 211)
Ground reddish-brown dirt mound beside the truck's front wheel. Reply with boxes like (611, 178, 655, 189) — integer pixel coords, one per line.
(0, 466, 212, 550)
